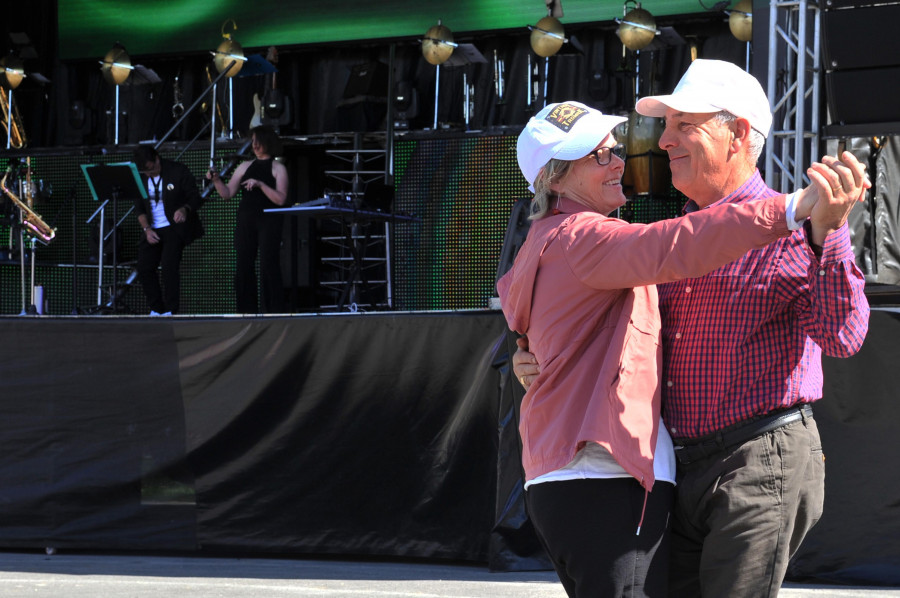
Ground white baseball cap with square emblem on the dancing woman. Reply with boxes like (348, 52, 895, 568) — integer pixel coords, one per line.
(516, 102, 628, 192)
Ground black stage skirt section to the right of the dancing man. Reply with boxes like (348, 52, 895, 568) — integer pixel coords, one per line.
(788, 309, 900, 585)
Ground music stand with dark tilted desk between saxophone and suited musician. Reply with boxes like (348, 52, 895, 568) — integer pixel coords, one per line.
(81, 162, 147, 312)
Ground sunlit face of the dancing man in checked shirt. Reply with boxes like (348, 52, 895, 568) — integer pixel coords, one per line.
(659, 108, 734, 207)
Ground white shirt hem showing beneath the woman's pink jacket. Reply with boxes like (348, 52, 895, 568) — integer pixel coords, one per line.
(525, 419, 675, 490)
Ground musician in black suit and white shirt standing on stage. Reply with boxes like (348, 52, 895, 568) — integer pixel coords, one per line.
(134, 145, 203, 315)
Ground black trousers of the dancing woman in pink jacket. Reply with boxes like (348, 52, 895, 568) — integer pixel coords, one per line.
(525, 478, 675, 598)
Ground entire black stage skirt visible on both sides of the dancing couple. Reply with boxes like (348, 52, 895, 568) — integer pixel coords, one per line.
(0, 310, 900, 585)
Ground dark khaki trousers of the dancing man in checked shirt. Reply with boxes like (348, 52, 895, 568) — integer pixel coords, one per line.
(669, 417, 825, 598)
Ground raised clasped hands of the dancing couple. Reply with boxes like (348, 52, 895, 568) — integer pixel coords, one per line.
(806, 152, 872, 246)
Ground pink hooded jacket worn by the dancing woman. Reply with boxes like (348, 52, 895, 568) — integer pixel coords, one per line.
(497, 196, 790, 491)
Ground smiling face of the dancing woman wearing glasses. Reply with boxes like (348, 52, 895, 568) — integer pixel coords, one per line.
(551, 134, 627, 215)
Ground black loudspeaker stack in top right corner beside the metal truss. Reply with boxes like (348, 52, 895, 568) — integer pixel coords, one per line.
(823, 0, 900, 125)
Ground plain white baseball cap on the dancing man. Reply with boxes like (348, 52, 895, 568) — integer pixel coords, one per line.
(634, 58, 772, 137)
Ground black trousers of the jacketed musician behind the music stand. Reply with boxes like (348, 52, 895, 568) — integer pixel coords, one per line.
(137, 226, 184, 314)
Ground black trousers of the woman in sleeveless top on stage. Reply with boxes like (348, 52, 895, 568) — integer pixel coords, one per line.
(234, 210, 284, 314)
